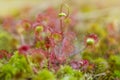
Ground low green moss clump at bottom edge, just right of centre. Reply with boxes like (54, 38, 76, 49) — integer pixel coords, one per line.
(57, 65, 83, 80)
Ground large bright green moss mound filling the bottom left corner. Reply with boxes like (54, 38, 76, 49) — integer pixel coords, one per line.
(0, 52, 32, 80)
